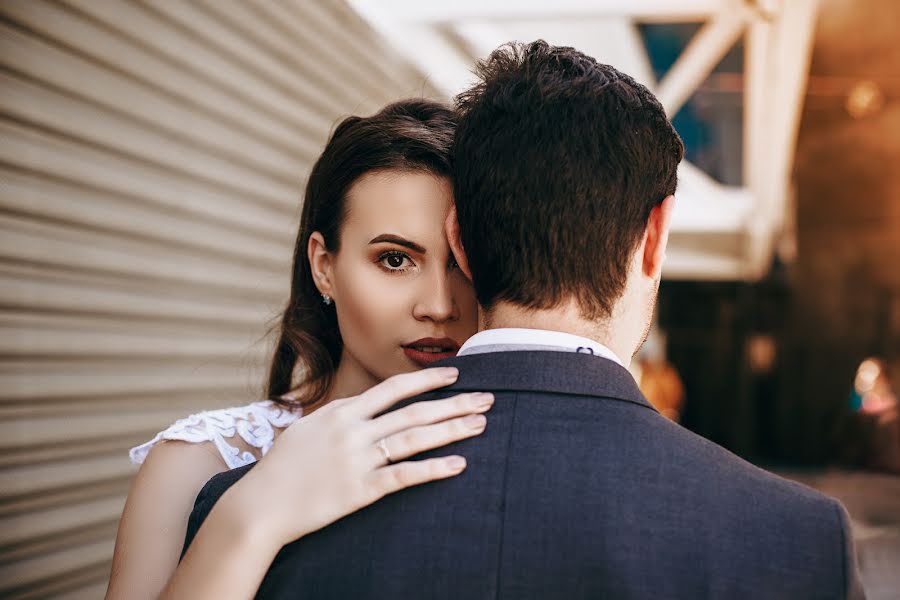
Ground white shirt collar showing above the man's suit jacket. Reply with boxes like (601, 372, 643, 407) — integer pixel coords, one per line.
(457, 327, 624, 366)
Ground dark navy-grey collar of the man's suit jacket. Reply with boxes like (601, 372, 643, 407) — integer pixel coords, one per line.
(434, 351, 656, 411)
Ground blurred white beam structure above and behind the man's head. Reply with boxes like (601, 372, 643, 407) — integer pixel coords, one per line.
(350, 0, 818, 281)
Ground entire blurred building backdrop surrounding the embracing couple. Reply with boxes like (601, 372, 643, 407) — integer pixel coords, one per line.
(0, 0, 900, 598)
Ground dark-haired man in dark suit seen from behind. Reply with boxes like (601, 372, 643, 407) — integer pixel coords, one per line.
(188, 41, 859, 599)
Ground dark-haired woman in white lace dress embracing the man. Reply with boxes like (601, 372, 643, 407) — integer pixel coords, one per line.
(107, 100, 493, 598)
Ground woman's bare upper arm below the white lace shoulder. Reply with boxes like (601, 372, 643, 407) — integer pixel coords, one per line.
(106, 441, 228, 600)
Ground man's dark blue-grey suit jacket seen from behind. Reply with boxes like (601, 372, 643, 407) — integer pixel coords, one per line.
(186, 352, 861, 600)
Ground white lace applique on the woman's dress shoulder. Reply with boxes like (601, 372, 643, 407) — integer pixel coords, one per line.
(128, 400, 300, 469)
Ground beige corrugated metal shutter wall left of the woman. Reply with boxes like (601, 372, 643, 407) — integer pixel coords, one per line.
(0, 0, 431, 598)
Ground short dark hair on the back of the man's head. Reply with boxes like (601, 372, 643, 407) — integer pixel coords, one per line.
(451, 40, 684, 319)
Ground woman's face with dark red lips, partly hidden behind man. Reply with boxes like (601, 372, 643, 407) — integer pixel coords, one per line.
(309, 171, 478, 386)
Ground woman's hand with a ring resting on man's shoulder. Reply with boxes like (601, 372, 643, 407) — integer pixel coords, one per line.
(220, 367, 494, 549)
